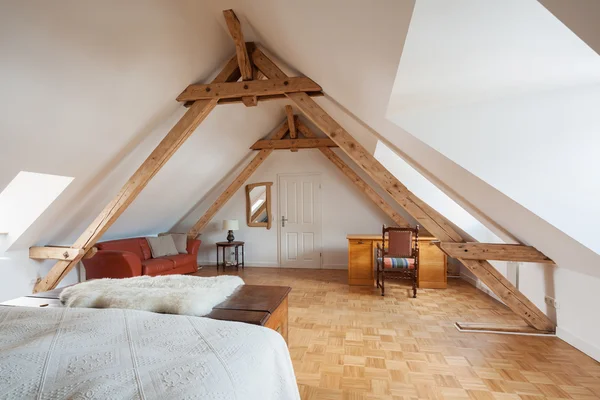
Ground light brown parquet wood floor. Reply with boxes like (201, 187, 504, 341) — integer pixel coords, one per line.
(193, 267, 600, 400)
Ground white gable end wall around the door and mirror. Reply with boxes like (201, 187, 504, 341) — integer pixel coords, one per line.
(172, 150, 412, 269)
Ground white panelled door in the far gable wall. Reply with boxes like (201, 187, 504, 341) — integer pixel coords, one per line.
(278, 174, 321, 268)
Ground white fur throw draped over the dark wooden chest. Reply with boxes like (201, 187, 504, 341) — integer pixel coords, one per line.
(60, 275, 244, 317)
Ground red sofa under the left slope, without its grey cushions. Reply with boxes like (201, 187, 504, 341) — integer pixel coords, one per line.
(82, 237, 200, 279)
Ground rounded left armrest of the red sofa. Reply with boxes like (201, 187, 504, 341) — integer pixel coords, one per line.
(82, 250, 142, 279)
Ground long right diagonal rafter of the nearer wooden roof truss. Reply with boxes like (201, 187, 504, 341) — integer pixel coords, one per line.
(251, 48, 555, 331)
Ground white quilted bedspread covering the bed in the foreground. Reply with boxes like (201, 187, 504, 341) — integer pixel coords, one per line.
(0, 306, 300, 400)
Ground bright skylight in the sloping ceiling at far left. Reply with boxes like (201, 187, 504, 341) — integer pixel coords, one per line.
(0, 171, 73, 241)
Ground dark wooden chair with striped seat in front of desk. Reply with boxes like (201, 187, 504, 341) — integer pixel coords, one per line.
(376, 225, 419, 298)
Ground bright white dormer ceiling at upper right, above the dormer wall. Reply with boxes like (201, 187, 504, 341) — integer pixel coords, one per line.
(388, 0, 600, 116)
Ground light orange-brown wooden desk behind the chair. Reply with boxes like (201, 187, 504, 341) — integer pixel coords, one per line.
(346, 234, 447, 289)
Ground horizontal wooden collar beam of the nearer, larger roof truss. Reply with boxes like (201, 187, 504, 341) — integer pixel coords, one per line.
(177, 77, 322, 101)
